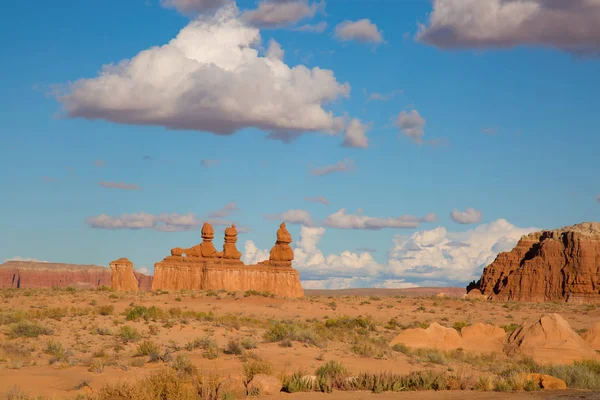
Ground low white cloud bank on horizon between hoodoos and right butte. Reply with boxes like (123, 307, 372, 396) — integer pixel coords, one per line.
(244, 219, 538, 289)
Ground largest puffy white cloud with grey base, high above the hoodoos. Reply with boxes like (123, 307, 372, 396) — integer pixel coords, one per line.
(57, 4, 350, 141)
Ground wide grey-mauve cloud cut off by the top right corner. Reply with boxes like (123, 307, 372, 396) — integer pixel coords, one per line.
(416, 0, 600, 53)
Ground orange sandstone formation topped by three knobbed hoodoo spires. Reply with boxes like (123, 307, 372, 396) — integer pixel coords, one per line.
(152, 223, 304, 297)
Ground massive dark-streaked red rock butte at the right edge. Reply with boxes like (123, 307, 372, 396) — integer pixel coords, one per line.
(468, 222, 600, 303)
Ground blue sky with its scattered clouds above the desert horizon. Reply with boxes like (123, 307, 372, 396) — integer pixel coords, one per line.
(0, 0, 600, 288)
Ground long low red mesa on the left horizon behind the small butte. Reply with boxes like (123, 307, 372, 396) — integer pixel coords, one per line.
(0, 261, 152, 290)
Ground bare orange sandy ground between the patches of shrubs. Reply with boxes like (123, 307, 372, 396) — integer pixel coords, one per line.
(0, 289, 600, 400)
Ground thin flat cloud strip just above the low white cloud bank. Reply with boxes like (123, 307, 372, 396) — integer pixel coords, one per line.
(325, 208, 436, 230)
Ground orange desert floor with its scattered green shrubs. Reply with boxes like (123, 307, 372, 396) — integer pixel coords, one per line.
(0, 289, 600, 400)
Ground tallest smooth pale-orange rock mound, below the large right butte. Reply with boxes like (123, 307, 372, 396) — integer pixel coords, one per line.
(505, 314, 598, 364)
